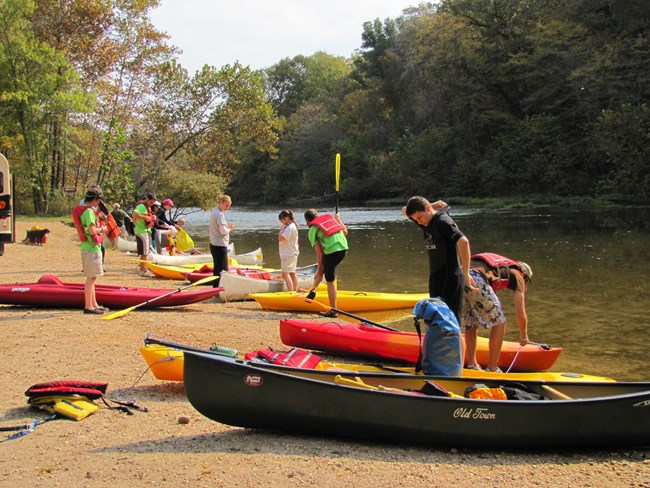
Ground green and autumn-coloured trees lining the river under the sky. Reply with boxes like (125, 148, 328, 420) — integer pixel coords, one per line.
(0, 0, 650, 213)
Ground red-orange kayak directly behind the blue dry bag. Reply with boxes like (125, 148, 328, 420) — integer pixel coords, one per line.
(280, 319, 562, 371)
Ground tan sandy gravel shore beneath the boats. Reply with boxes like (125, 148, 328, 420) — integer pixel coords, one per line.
(0, 221, 650, 488)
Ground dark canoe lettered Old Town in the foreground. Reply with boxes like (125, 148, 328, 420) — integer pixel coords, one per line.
(185, 352, 650, 448)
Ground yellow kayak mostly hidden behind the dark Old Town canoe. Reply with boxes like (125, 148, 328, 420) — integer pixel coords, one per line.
(140, 344, 614, 382)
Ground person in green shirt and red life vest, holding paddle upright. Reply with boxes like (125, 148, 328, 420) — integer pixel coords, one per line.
(305, 208, 348, 317)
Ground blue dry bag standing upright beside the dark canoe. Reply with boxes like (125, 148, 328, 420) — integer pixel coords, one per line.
(413, 297, 463, 376)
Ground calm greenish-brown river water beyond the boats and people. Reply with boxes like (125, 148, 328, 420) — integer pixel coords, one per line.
(180, 207, 650, 381)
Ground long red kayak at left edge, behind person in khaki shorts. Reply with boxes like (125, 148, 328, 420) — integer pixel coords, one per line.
(0, 274, 223, 309)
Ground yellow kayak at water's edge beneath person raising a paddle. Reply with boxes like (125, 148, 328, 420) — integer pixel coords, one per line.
(251, 290, 429, 313)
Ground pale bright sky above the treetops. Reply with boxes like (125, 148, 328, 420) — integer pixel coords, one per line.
(150, 0, 410, 73)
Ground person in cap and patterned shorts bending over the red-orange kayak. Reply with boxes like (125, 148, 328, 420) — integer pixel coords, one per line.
(461, 253, 533, 371)
